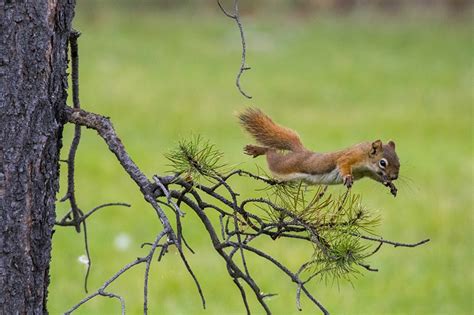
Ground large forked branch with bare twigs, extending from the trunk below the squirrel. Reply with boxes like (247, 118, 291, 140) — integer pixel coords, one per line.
(59, 103, 427, 314)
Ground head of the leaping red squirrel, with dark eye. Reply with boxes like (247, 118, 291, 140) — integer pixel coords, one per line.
(369, 140, 400, 183)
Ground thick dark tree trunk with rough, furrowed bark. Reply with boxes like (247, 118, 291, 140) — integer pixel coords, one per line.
(0, 0, 75, 314)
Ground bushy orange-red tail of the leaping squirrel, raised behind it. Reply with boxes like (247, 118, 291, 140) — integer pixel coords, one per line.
(239, 108, 304, 151)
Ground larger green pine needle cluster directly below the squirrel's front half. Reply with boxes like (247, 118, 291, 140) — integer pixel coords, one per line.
(267, 182, 380, 281)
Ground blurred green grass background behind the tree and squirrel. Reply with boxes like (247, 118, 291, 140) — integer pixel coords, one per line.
(48, 1, 474, 314)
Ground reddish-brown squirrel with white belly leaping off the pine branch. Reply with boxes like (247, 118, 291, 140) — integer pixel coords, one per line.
(239, 108, 400, 196)
